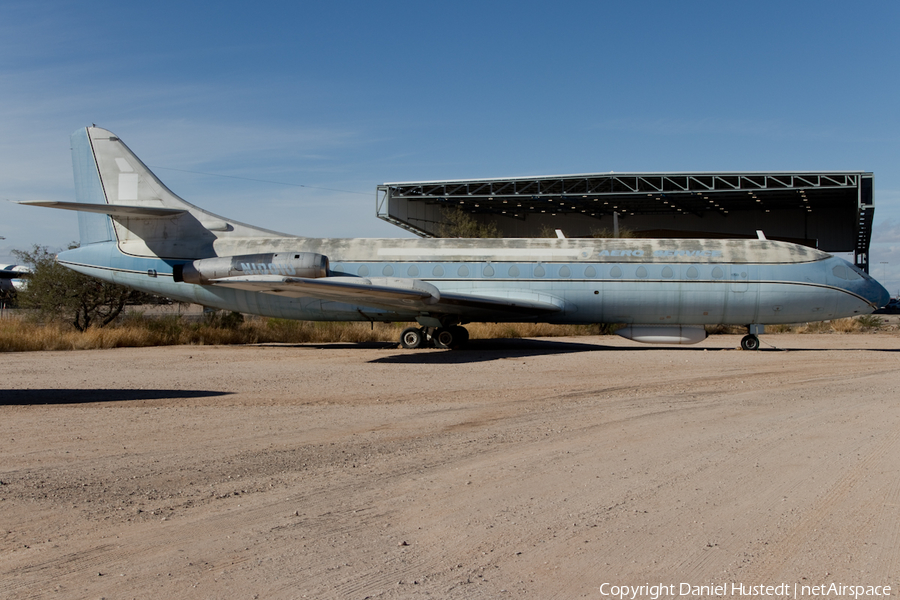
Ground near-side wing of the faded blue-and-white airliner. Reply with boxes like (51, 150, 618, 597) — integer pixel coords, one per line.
(210, 275, 562, 318)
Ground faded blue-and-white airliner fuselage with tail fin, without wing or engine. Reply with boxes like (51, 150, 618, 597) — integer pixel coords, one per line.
(38, 127, 887, 332)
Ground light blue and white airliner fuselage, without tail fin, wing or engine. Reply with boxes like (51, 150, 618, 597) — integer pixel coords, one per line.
(59, 238, 881, 325)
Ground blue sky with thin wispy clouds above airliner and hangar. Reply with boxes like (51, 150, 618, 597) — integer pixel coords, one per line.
(0, 0, 900, 294)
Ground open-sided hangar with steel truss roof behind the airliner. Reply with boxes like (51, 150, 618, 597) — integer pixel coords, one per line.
(376, 171, 874, 272)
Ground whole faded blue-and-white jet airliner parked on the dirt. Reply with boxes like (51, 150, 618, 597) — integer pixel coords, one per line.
(23, 127, 888, 349)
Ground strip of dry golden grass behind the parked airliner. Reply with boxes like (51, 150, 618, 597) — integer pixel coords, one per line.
(0, 313, 882, 352)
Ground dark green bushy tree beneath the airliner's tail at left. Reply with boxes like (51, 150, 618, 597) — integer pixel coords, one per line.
(13, 244, 158, 331)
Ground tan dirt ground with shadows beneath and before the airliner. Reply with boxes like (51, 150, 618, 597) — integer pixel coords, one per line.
(0, 332, 900, 600)
